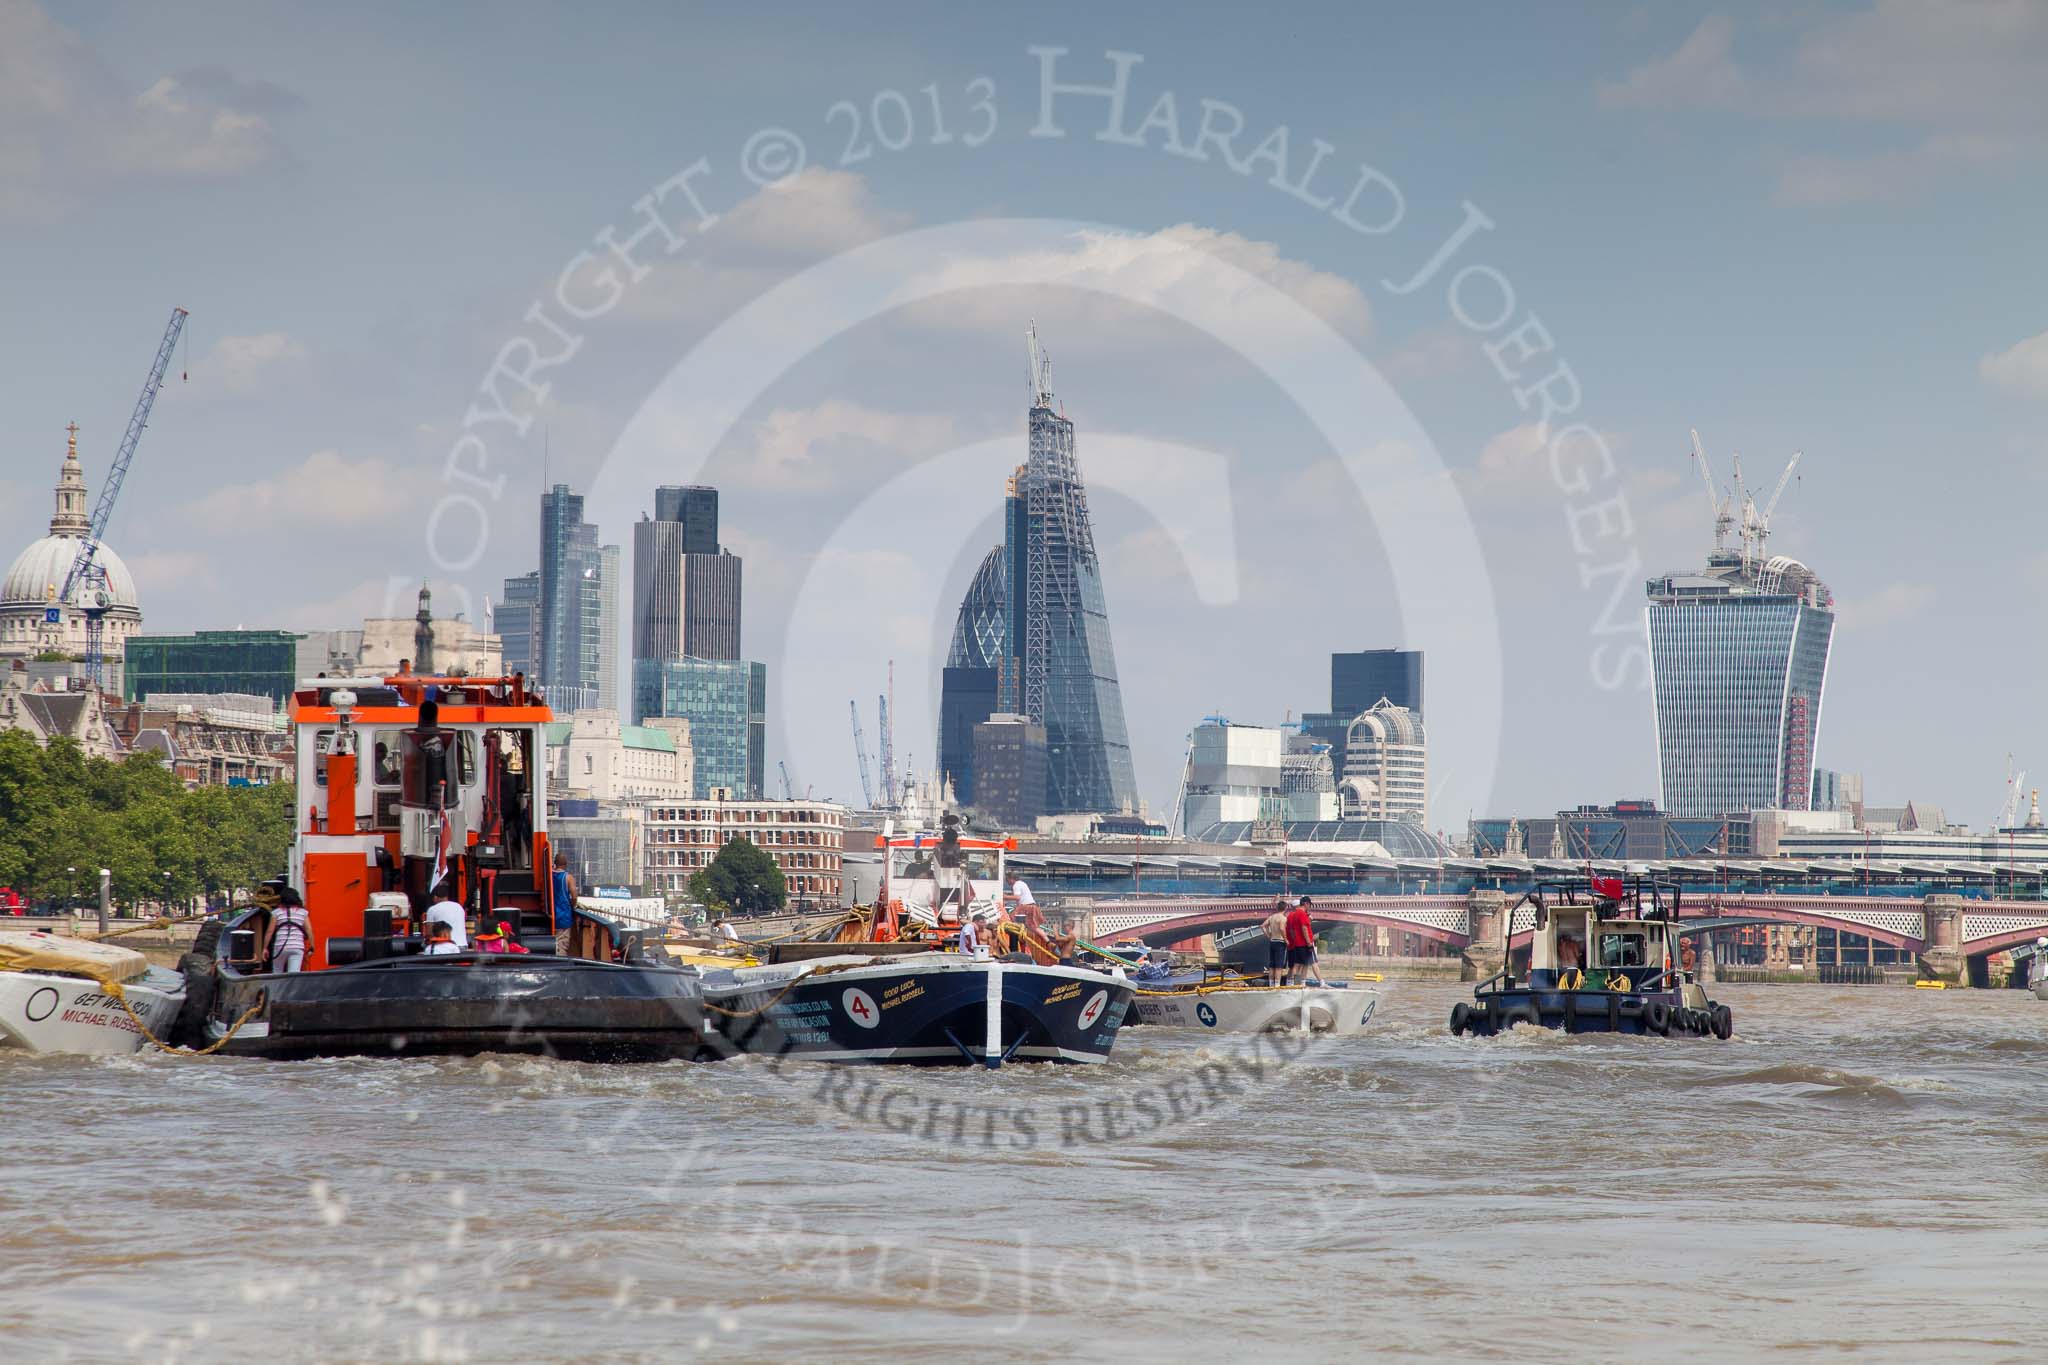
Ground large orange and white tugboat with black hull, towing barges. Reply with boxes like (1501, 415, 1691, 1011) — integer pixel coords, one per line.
(182, 671, 702, 1062)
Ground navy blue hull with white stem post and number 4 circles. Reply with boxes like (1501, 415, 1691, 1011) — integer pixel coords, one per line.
(705, 962, 1133, 1066)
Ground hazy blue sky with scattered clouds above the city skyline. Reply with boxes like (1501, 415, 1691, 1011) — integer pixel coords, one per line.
(0, 0, 2048, 829)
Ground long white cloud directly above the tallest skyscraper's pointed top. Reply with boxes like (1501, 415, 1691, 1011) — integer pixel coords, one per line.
(911, 223, 1372, 340)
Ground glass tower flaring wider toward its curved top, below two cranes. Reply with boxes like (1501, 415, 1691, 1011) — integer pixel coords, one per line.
(1645, 551, 1835, 817)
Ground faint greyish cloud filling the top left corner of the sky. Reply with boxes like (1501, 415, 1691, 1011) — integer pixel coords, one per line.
(0, 0, 297, 219)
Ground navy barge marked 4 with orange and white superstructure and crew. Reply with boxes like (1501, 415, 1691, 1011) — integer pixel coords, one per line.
(705, 814, 1133, 1068)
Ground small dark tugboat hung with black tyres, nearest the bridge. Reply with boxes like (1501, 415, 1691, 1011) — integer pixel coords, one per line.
(1450, 876, 1735, 1040)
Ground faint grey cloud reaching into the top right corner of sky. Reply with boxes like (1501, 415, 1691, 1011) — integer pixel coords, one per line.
(1597, 0, 2048, 205)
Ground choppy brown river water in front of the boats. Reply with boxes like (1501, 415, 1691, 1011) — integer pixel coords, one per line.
(0, 982, 2048, 1363)
